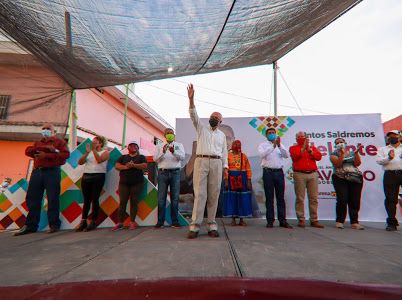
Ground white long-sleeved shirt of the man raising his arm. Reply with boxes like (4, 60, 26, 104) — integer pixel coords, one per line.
(189, 108, 228, 168)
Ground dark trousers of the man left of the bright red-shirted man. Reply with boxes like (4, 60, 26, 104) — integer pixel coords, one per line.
(262, 168, 286, 224)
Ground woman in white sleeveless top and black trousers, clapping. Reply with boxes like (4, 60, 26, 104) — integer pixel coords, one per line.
(76, 136, 110, 232)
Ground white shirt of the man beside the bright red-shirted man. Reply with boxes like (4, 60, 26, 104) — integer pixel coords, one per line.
(258, 141, 289, 169)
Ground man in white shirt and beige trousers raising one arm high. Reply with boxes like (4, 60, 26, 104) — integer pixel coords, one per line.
(187, 83, 228, 239)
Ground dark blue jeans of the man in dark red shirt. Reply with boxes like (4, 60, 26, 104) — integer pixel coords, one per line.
(25, 167, 61, 231)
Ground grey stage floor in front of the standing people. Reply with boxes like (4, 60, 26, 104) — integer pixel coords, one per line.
(0, 219, 402, 286)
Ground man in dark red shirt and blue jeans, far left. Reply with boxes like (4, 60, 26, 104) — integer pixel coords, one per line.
(14, 123, 70, 236)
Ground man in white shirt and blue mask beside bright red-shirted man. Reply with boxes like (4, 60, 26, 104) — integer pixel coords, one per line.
(258, 128, 292, 229)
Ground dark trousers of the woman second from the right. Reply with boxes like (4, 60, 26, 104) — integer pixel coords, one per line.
(332, 174, 363, 224)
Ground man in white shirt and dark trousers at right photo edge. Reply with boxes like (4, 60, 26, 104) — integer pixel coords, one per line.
(377, 130, 402, 231)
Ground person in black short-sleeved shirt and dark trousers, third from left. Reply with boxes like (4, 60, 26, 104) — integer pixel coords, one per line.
(112, 141, 147, 231)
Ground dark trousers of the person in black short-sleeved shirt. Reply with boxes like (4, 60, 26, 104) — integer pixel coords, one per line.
(119, 182, 144, 223)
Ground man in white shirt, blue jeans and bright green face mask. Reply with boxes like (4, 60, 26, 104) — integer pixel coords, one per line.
(153, 128, 185, 228)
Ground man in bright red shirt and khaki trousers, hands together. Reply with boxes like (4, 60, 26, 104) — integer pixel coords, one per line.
(289, 131, 324, 228)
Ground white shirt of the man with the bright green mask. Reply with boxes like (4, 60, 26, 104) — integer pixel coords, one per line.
(154, 142, 185, 169)
